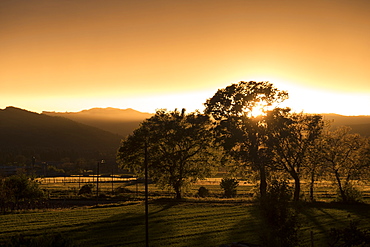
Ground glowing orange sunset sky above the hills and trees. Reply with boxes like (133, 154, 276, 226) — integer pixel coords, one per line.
(0, 0, 370, 115)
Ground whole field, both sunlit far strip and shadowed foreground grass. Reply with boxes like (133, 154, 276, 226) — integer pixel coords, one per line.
(0, 179, 370, 247)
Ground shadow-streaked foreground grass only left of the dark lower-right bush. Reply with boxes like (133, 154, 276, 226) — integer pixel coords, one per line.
(0, 202, 258, 246)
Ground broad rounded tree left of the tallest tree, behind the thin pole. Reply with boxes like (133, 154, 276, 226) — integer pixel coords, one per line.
(118, 109, 220, 199)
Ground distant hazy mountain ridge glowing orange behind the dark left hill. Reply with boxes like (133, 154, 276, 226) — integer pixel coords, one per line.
(42, 107, 153, 136)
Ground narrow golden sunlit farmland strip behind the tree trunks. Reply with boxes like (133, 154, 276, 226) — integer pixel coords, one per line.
(37, 177, 370, 203)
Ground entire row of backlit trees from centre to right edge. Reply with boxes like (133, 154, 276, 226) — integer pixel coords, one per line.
(117, 81, 370, 202)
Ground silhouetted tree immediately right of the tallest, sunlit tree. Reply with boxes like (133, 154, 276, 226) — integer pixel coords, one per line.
(266, 108, 324, 201)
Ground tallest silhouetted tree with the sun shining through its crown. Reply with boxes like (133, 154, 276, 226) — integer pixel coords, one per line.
(205, 81, 288, 198)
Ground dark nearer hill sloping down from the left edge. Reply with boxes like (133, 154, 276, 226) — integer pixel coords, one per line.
(0, 107, 122, 161)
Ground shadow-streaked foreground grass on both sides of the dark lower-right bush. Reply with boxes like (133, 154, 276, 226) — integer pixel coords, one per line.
(0, 200, 370, 247)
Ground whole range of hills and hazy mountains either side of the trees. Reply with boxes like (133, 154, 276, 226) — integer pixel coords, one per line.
(0, 107, 370, 161)
